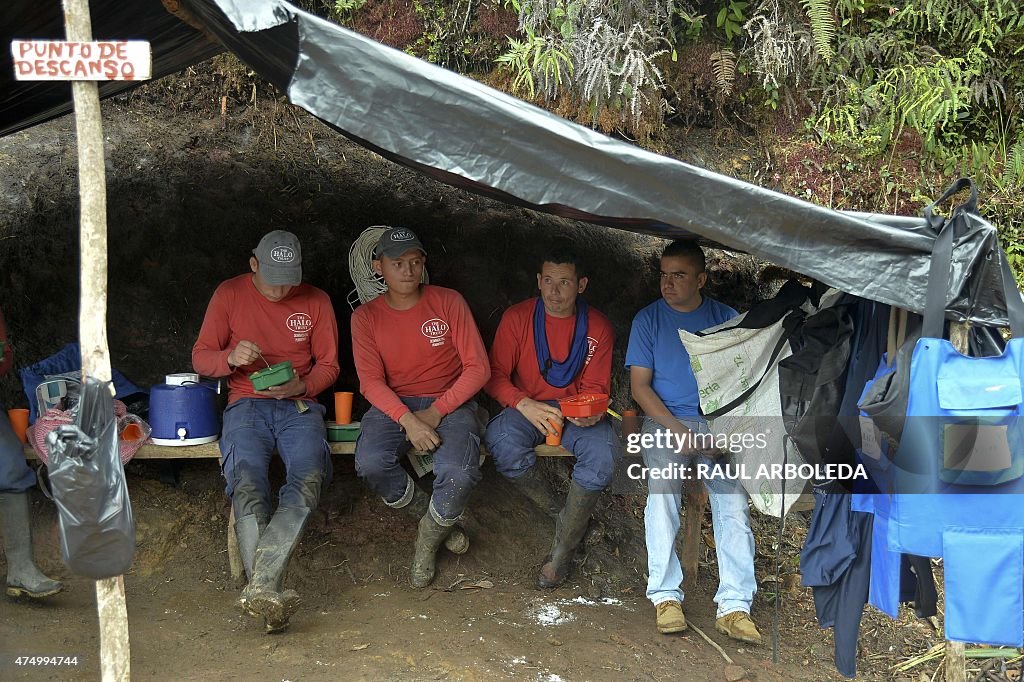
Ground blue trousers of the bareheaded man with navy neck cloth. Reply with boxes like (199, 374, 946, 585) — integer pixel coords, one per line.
(483, 401, 622, 491)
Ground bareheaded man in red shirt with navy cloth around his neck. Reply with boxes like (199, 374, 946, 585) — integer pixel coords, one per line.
(484, 250, 620, 587)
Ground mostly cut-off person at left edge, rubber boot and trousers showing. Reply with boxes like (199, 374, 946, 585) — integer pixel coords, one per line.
(0, 305, 63, 599)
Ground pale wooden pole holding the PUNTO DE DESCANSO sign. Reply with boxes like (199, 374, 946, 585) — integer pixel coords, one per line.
(62, 0, 131, 682)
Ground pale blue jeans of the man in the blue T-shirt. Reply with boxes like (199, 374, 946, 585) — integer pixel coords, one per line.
(642, 418, 758, 617)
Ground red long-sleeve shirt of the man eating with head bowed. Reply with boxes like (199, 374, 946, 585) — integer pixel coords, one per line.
(193, 273, 341, 402)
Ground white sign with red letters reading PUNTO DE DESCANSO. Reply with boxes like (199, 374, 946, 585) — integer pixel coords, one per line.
(10, 40, 153, 81)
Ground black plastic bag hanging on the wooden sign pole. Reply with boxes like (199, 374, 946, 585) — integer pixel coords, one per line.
(46, 378, 135, 580)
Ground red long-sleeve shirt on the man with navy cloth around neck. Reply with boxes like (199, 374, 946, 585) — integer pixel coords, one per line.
(484, 298, 615, 408)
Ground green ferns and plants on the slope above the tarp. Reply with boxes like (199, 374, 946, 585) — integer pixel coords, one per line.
(313, 0, 1024, 272)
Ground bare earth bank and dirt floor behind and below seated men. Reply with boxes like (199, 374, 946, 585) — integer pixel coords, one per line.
(0, 61, 958, 681)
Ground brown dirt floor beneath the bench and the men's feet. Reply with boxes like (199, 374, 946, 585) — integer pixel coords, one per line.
(0, 456, 937, 681)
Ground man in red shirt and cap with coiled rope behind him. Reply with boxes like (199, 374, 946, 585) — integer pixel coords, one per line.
(352, 227, 489, 588)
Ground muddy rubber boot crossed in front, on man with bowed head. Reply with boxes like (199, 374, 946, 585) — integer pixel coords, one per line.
(239, 507, 309, 633)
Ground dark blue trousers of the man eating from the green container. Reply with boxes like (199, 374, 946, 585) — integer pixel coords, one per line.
(220, 398, 333, 518)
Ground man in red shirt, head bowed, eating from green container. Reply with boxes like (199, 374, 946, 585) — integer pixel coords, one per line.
(193, 229, 339, 632)
